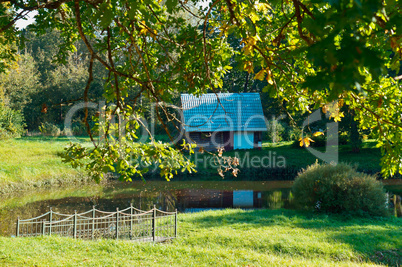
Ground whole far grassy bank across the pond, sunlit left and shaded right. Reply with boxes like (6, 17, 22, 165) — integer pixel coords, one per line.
(0, 136, 390, 194)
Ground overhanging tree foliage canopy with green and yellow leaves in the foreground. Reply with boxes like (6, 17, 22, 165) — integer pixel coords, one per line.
(0, 0, 402, 179)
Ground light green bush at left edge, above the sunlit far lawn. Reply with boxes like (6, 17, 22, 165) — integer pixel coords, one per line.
(0, 103, 25, 139)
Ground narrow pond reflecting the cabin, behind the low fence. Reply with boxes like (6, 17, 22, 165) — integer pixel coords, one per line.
(0, 180, 402, 236)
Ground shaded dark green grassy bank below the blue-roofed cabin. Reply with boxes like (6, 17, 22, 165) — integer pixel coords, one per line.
(145, 140, 381, 181)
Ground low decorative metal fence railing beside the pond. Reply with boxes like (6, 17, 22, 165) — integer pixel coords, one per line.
(16, 205, 177, 242)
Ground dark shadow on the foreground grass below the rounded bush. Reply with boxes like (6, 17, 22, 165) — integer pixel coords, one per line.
(189, 209, 402, 266)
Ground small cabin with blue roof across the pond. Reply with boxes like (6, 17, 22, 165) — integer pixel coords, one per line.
(181, 93, 267, 150)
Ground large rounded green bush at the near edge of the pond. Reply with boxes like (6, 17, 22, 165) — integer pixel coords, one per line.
(292, 163, 387, 216)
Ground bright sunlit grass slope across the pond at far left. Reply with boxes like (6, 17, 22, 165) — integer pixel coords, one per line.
(0, 137, 95, 193)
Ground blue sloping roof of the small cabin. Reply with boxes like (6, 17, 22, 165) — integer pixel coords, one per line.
(181, 93, 267, 132)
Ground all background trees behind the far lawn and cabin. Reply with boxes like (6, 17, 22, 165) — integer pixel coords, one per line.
(0, 28, 361, 155)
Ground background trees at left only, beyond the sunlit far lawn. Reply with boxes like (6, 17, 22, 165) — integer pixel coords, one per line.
(0, 30, 105, 134)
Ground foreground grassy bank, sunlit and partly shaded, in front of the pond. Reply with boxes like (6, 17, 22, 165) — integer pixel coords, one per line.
(0, 209, 402, 266)
